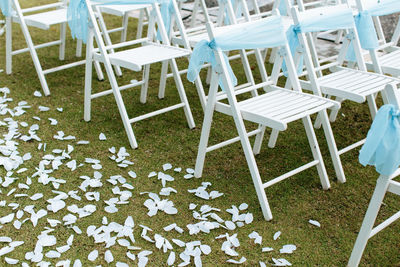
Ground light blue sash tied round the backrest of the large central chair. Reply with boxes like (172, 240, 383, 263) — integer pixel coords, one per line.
(187, 16, 287, 89)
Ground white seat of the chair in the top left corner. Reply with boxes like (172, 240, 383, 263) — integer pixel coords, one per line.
(13, 8, 67, 30)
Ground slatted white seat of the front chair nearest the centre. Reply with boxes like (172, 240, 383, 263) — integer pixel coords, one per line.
(216, 89, 340, 131)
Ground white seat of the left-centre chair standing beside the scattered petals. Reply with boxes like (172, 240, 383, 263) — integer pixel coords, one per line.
(94, 43, 190, 71)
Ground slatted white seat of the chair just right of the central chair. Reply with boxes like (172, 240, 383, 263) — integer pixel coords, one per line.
(318, 68, 399, 103)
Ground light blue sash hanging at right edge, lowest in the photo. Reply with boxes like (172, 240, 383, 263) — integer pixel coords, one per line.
(359, 105, 400, 175)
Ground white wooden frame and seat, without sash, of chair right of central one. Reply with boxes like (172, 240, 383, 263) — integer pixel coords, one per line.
(292, 4, 400, 182)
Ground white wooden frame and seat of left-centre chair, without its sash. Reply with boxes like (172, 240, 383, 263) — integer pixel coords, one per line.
(84, 0, 195, 148)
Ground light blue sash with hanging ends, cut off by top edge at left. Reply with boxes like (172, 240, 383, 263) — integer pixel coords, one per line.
(68, 0, 174, 43)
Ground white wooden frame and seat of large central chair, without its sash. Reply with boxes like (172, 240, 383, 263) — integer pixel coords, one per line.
(195, 17, 343, 220)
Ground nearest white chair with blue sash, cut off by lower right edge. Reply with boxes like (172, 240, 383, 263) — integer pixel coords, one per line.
(347, 84, 400, 267)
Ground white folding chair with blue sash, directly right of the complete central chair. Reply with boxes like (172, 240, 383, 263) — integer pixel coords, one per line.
(276, 4, 399, 182)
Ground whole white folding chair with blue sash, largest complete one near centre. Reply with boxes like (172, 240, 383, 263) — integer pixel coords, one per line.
(188, 16, 341, 220)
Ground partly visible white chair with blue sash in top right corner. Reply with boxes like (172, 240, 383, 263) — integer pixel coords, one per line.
(350, 0, 400, 77)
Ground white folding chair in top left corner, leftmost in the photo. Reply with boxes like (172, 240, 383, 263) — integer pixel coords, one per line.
(6, 0, 91, 95)
